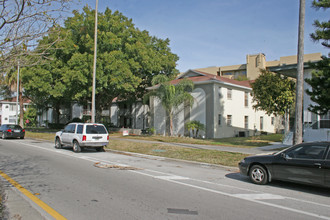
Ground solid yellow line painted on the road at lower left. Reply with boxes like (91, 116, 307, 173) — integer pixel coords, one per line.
(0, 170, 66, 220)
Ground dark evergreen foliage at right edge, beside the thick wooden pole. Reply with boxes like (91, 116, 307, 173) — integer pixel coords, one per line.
(305, 0, 330, 115)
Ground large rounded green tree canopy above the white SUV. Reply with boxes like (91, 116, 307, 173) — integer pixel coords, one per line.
(24, 7, 178, 123)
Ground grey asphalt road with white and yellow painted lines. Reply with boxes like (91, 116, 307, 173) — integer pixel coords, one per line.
(0, 139, 330, 220)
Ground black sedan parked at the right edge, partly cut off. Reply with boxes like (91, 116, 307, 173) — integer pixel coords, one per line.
(239, 142, 330, 187)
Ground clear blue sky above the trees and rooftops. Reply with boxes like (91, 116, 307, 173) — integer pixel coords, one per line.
(73, 0, 330, 72)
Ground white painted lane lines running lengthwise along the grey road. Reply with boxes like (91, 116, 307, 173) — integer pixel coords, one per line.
(14, 140, 330, 220)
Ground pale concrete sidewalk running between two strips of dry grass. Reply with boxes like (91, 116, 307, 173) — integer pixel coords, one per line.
(110, 137, 288, 154)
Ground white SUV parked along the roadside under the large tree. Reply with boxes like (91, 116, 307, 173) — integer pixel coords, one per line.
(55, 123, 109, 152)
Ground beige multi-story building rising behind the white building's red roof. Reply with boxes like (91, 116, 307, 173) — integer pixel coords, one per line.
(196, 53, 321, 80)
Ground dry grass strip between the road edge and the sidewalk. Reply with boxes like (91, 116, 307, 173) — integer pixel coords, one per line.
(107, 140, 248, 167)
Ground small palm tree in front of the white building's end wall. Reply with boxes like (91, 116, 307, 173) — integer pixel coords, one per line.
(148, 75, 194, 136)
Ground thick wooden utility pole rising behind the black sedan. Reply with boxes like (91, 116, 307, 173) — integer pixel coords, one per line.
(293, 0, 305, 144)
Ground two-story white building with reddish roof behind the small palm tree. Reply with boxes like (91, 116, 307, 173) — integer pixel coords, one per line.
(150, 70, 280, 138)
